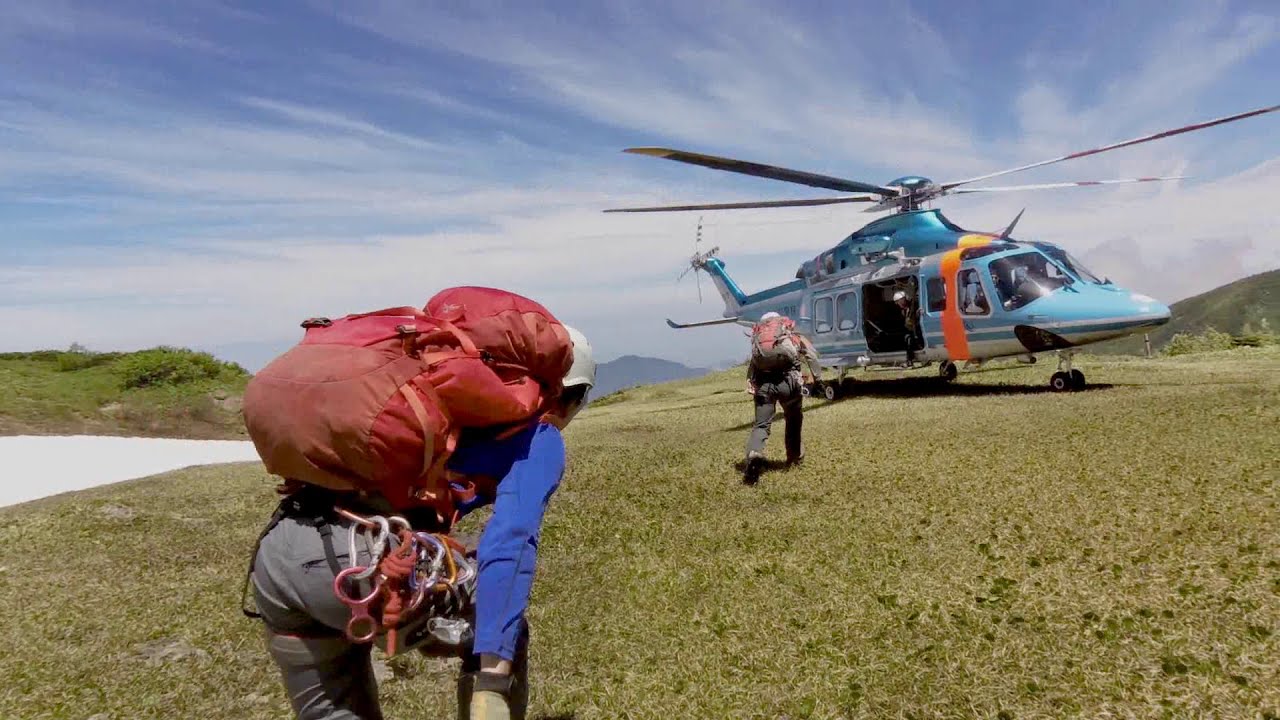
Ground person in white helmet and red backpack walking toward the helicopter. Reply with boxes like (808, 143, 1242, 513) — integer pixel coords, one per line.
(744, 313, 822, 484)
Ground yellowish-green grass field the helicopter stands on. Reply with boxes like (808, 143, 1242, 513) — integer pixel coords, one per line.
(0, 347, 1280, 720)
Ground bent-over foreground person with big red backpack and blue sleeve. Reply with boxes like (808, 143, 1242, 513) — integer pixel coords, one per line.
(244, 287, 595, 720)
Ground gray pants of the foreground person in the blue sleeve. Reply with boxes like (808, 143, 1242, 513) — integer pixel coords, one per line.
(251, 504, 529, 720)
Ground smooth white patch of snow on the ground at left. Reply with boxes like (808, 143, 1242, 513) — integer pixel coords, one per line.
(0, 436, 260, 507)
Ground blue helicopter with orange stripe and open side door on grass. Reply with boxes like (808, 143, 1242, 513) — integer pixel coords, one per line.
(604, 105, 1280, 400)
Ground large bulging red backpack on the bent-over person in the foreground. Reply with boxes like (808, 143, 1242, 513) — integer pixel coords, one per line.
(243, 287, 573, 524)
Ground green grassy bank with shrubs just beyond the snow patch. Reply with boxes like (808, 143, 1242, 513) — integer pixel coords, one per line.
(0, 348, 248, 439)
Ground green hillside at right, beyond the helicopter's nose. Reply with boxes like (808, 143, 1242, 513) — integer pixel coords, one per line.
(1089, 269, 1280, 355)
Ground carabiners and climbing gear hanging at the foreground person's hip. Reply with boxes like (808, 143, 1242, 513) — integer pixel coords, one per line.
(333, 507, 477, 656)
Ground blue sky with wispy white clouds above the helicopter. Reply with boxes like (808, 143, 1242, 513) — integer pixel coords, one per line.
(0, 0, 1280, 365)
